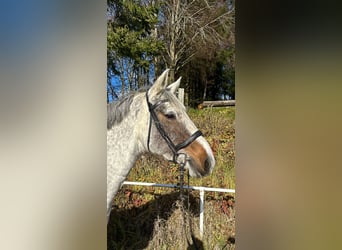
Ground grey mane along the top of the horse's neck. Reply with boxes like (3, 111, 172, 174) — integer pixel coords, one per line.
(107, 92, 138, 130)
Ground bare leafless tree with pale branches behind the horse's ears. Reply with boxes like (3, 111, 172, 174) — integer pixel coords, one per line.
(159, 0, 235, 81)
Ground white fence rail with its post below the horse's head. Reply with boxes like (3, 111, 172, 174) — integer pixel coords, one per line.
(123, 181, 235, 237)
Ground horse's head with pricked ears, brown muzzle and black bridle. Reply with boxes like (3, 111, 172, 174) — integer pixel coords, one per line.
(146, 70, 215, 177)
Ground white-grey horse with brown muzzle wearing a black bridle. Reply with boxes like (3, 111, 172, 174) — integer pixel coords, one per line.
(107, 69, 215, 222)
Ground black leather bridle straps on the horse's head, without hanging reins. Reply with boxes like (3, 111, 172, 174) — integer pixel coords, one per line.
(146, 90, 202, 163)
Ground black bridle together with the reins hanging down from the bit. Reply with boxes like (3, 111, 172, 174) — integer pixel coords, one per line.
(146, 90, 202, 249)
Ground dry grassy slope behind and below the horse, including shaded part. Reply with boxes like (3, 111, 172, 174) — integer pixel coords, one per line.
(107, 107, 235, 249)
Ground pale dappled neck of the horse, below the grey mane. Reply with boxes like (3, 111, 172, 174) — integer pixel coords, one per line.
(107, 93, 149, 220)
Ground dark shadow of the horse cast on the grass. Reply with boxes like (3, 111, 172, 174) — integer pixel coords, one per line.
(107, 192, 203, 250)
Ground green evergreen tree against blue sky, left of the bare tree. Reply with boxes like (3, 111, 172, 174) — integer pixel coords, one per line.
(107, 0, 162, 100)
